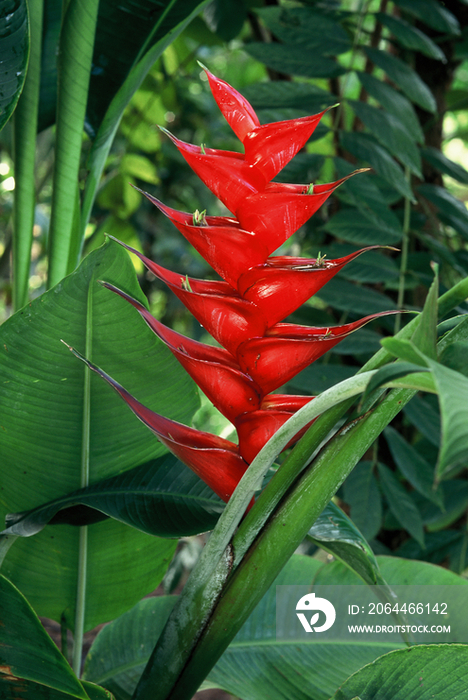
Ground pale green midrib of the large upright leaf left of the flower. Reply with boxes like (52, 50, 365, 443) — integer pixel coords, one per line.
(72, 285, 93, 677)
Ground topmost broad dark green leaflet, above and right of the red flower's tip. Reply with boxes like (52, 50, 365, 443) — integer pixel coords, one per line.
(256, 7, 351, 56)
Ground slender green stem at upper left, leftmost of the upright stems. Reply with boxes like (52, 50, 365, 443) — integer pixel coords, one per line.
(13, 0, 43, 311)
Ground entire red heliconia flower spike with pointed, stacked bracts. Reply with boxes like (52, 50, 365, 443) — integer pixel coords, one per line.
(92, 70, 393, 500)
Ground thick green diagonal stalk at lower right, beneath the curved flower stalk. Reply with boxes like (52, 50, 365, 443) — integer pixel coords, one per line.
(152, 382, 416, 700)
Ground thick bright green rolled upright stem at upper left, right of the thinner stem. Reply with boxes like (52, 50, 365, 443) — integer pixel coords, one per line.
(48, 0, 99, 287)
